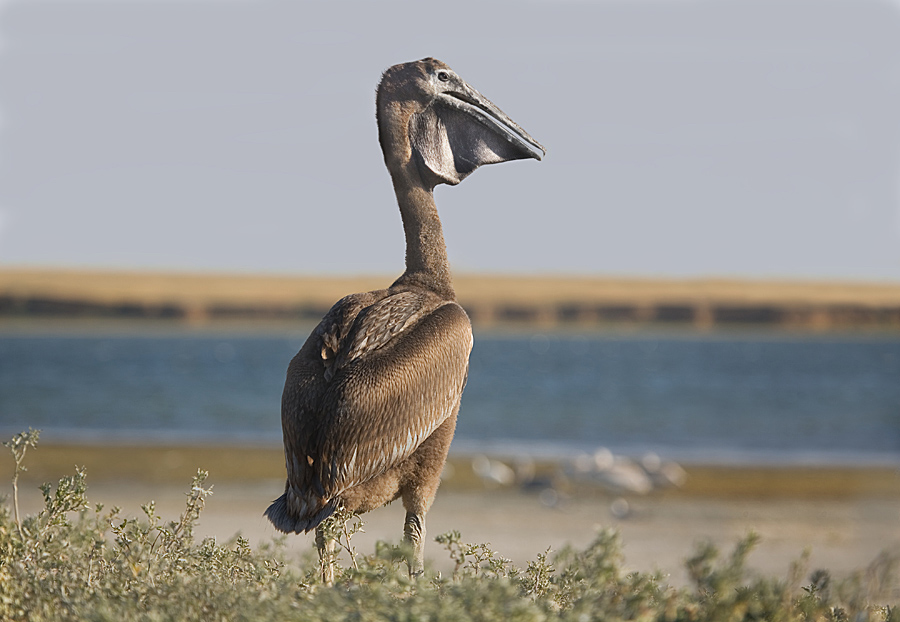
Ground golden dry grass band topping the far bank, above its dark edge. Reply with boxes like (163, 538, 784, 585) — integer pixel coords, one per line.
(0, 269, 900, 307)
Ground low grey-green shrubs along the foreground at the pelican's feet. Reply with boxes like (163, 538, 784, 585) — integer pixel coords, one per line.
(0, 431, 900, 622)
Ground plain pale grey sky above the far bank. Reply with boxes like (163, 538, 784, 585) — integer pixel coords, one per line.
(0, 0, 900, 282)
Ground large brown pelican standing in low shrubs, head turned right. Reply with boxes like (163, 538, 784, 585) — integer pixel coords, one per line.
(266, 58, 544, 574)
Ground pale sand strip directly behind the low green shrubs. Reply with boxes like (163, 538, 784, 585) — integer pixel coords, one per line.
(8, 464, 900, 584)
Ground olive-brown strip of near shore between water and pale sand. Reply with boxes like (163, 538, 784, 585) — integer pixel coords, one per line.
(0, 441, 900, 499)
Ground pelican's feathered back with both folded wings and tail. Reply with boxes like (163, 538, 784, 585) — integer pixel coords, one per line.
(267, 290, 472, 532)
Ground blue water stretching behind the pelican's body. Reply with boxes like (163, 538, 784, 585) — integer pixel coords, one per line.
(0, 332, 900, 463)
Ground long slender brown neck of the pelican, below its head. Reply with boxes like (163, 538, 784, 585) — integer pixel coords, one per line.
(391, 162, 456, 300)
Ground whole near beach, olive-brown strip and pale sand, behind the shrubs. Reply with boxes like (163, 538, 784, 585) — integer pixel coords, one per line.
(8, 445, 900, 586)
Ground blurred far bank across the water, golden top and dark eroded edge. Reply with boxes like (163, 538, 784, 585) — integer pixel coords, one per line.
(0, 269, 900, 330)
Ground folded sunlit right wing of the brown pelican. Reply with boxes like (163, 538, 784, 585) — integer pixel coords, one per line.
(311, 300, 472, 498)
